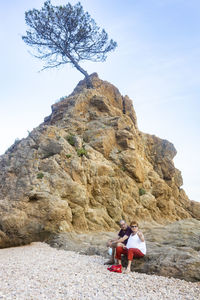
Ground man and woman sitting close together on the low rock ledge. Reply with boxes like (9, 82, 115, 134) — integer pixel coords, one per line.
(105, 220, 146, 273)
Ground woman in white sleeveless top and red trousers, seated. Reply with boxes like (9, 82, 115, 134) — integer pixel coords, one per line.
(116, 221, 146, 273)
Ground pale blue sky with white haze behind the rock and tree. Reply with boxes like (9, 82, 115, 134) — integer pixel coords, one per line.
(0, 0, 200, 201)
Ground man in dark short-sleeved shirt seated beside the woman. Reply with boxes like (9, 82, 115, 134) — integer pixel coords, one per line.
(105, 220, 132, 265)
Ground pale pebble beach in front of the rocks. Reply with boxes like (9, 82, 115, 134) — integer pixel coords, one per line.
(0, 243, 200, 300)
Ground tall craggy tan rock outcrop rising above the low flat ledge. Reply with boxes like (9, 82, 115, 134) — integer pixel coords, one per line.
(0, 74, 200, 247)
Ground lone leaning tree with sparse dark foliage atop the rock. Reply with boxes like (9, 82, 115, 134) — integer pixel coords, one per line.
(22, 0, 117, 87)
